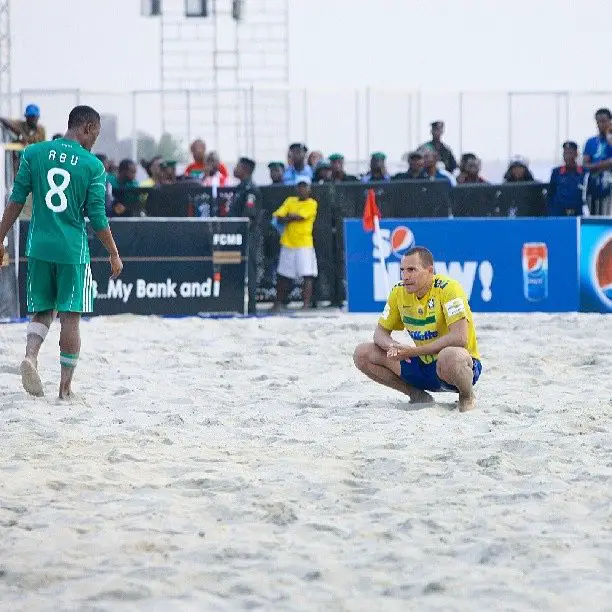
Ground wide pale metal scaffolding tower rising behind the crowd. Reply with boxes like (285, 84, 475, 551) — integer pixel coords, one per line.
(148, 0, 289, 163)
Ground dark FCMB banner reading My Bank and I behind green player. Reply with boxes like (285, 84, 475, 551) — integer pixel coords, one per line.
(19, 218, 248, 316)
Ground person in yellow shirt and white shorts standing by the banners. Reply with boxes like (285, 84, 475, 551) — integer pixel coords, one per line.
(272, 176, 317, 312)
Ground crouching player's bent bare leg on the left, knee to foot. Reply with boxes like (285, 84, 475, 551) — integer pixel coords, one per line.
(353, 342, 434, 403)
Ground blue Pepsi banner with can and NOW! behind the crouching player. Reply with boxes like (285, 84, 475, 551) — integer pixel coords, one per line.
(345, 217, 580, 312)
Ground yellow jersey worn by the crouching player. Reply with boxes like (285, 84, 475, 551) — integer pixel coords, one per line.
(378, 274, 480, 363)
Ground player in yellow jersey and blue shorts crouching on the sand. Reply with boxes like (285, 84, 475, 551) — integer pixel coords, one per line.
(353, 246, 482, 412)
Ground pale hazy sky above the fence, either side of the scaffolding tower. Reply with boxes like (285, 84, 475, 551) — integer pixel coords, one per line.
(11, 0, 612, 91)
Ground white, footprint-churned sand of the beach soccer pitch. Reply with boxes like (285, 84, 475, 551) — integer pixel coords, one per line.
(0, 315, 612, 612)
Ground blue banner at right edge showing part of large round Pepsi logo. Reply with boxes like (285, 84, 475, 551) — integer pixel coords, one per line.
(580, 217, 612, 312)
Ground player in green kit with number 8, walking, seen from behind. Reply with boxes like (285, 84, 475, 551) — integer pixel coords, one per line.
(0, 106, 123, 399)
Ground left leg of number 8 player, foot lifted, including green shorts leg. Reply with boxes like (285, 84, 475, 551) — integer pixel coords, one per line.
(20, 258, 57, 397)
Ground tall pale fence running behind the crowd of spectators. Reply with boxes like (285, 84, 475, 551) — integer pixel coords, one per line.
(5, 88, 612, 179)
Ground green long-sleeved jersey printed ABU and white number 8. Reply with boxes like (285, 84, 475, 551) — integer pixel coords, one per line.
(11, 138, 108, 264)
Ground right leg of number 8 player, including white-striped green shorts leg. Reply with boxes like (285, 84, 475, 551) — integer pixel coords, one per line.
(57, 264, 93, 399)
